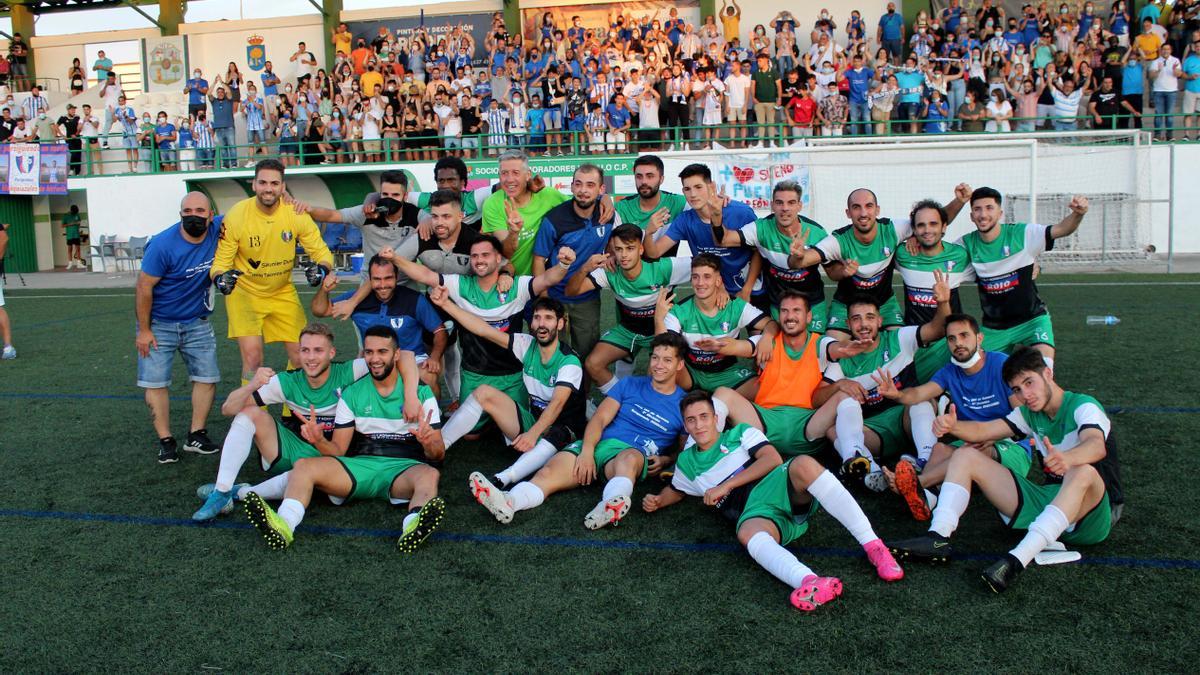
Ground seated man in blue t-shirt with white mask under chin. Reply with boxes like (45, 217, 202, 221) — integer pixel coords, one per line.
(875, 313, 1031, 520)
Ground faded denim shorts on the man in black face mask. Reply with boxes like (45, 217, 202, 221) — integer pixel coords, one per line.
(138, 318, 221, 389)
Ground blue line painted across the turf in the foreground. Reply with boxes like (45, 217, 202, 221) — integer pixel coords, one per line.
(0, 509, 1200, 571)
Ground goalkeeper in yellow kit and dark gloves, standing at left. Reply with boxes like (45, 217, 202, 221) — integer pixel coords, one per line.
(210, 160, 337, 381)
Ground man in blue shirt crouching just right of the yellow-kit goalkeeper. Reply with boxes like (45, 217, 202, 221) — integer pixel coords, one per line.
(312, 255, 449, 395)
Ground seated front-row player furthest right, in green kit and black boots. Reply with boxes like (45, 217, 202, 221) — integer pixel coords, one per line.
(890, 346, 1124, 593)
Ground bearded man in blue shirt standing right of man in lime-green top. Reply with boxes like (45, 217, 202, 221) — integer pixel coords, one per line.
(533, 163, 619, 358)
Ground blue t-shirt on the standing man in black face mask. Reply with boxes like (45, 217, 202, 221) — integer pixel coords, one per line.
(142, 216, 222, 323)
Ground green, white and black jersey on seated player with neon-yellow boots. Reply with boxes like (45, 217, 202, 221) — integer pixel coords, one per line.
(334, 377, 442, 461)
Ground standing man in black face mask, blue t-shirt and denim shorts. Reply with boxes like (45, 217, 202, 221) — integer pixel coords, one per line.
(134, 192, 221, 464)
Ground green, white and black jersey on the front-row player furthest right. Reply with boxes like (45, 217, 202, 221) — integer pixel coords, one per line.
(1004, 392, 1123, 494)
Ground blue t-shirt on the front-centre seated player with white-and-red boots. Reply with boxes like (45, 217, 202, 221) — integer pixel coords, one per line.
(600, 375, 686, 456)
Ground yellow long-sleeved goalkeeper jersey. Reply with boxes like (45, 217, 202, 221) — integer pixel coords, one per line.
(212, 197, 334, 295)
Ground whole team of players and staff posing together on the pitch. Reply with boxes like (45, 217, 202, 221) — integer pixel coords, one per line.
(136, 150, 1123, 611)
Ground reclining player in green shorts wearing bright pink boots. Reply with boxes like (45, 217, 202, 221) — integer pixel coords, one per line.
(642, 392, 904, 611)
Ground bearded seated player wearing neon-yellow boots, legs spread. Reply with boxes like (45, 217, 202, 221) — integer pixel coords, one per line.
(245, 325, 445, 554)
